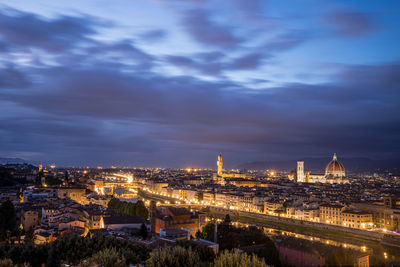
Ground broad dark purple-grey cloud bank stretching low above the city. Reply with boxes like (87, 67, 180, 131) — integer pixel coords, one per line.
(0, 60, 400, 165)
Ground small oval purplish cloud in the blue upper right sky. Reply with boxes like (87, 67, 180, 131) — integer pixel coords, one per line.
(324, 10, 379, 38)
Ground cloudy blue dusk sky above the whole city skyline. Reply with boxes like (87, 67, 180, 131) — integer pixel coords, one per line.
(0, 0, 400, 167)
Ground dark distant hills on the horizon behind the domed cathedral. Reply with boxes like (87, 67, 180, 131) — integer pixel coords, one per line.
(237, 157, 400, 173)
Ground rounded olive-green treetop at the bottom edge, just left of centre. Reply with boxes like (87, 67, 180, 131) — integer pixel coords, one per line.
(146, 246, 201, 267)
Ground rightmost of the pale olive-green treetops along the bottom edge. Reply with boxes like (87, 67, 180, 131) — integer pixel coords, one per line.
(214, 250, 267, 267)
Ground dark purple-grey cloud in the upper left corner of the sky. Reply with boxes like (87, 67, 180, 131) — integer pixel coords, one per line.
(0, 8, 109, 53)
